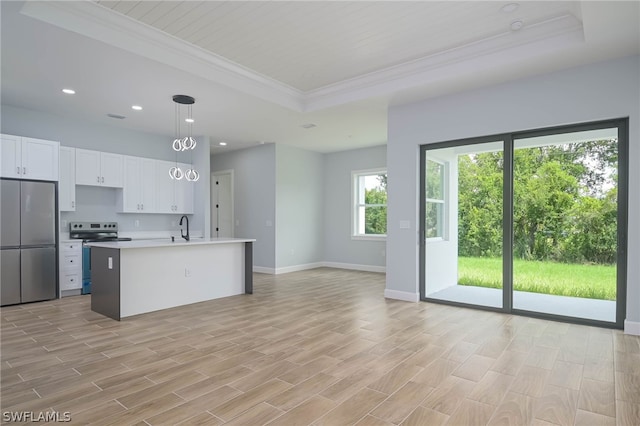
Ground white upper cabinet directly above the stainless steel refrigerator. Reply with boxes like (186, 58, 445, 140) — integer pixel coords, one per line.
(0, 135, 60, 181)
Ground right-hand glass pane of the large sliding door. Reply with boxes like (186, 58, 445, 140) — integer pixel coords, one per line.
(513, 127, 619, 322)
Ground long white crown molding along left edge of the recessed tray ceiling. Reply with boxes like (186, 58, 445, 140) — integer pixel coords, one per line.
(20, 1, 303, 111)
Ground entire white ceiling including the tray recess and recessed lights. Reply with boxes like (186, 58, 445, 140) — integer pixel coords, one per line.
(1, 1, 640, 153)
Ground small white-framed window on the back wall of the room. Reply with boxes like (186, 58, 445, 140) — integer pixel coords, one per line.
(351, 169, 387, 239)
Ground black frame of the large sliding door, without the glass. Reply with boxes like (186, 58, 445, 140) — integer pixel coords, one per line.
(418, 117, 629, 329)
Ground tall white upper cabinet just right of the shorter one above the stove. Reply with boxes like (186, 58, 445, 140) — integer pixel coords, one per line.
(118, 156, 156, 213)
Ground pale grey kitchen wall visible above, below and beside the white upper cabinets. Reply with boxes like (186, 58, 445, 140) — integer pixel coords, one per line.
(0, 105, 210, 235)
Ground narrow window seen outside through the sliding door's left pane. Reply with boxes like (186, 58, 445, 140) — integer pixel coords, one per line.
(425, 159, 445, 239)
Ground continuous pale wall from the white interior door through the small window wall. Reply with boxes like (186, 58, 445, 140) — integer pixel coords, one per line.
(211, 141, 386, 273)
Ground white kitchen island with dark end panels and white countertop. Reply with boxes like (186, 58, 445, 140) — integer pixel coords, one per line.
(89, 238, 255, 320)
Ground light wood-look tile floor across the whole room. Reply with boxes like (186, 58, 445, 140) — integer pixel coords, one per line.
(0, 268, 640, 426)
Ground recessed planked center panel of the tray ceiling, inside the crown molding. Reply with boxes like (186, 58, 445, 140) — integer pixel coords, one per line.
(97, 1, 580, 92)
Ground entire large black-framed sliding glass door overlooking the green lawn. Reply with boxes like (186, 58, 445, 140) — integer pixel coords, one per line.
(420, 119, 628, 327)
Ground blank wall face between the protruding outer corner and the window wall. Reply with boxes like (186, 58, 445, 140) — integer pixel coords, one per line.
(275, 145, 324, 272)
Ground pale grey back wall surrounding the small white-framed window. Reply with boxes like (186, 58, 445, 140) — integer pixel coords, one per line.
(324, 145, 387, 270)
